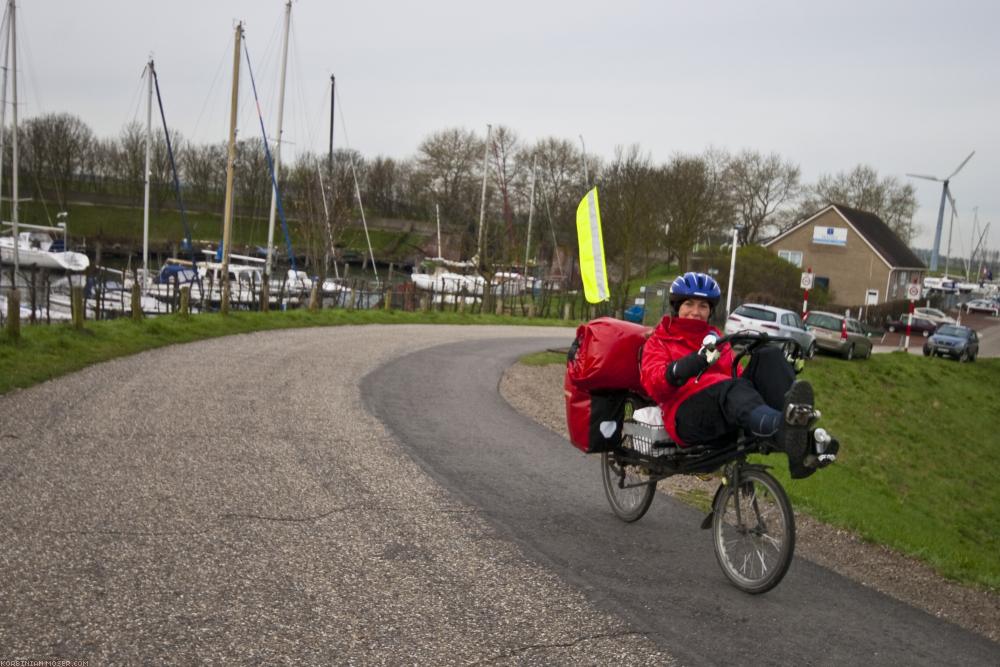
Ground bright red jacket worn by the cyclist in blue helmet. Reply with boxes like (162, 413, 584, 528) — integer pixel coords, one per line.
(640, 317, 733, 445)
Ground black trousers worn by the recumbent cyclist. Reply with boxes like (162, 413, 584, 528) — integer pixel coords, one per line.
(676, 347, 795, 446)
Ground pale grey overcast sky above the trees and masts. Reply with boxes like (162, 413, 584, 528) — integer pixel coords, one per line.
(9, 0, 1000, 255)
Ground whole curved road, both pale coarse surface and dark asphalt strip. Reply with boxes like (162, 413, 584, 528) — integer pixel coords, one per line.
(0, 326, 1000, 665)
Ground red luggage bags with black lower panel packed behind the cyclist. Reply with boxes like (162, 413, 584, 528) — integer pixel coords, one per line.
(563, 317, 649, 454)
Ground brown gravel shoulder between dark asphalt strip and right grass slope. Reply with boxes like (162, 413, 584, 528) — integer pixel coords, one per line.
(500, 364, 1000, 642)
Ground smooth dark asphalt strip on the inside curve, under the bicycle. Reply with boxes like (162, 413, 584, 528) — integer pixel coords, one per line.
(362, 341, 1000, 667)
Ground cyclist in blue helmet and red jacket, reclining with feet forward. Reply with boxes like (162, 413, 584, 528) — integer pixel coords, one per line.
(640, 272, 838, 478)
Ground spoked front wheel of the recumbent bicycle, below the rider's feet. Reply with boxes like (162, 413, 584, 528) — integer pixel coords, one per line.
(712, 469, 795, 594)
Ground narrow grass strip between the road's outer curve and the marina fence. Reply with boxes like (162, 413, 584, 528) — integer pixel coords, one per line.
(0, 309, 576, 394)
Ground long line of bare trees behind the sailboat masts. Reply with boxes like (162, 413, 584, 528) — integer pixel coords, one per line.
(2, 113, 916, 310)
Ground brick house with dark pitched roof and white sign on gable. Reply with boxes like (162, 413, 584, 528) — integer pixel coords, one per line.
(763, 204, 927, 305)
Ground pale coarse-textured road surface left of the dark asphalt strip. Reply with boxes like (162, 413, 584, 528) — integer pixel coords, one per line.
(0, 326, 673, 665)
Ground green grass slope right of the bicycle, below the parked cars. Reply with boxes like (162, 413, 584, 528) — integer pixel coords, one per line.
(536, 352, 1000, 591)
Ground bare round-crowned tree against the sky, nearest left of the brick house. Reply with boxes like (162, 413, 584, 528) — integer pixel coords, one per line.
(724, 150, 800, 246)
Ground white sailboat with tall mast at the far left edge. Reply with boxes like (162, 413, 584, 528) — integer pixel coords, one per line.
(0, 0, 90, 273)
